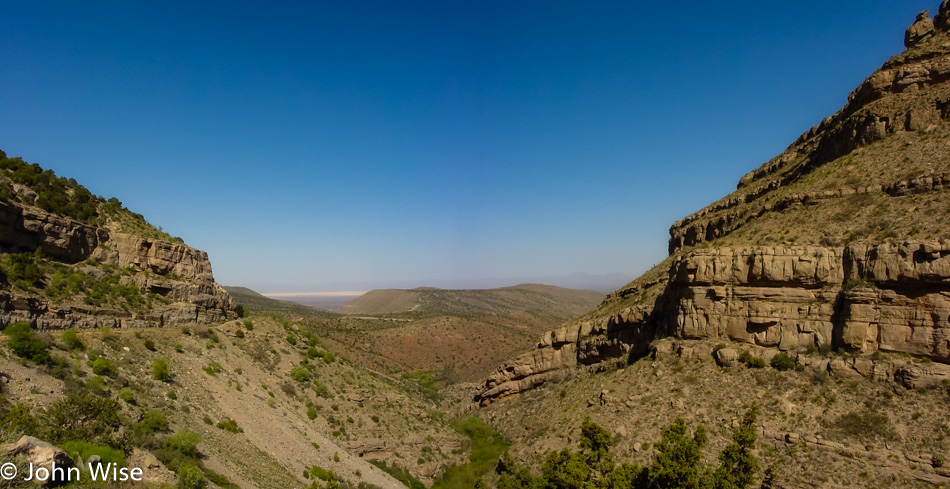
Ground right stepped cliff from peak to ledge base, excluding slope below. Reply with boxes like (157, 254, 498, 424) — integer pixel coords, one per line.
(475, 2, 950, 405)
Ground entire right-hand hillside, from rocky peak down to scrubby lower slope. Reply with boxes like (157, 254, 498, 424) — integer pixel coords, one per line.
(474, 2, 950, 488)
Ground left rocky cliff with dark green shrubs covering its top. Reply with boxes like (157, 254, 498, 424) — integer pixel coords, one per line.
(0, 152, 233, 329)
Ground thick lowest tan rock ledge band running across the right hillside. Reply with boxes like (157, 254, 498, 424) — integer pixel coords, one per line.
(475, 241, 950, 405)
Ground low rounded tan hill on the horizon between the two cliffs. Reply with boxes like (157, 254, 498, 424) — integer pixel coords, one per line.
(340, 284, 604, 320)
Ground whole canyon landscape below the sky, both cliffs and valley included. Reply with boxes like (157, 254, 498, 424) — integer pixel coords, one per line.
(0, 2, 950, 489)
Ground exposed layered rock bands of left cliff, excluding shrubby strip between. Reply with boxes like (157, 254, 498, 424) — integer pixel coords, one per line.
(0, 202, 234, 329)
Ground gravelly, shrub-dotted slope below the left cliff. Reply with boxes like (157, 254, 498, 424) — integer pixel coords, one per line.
(0, 315, 474, 488)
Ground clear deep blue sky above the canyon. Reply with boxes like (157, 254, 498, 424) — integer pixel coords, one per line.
(0, 0, 939, 291)
